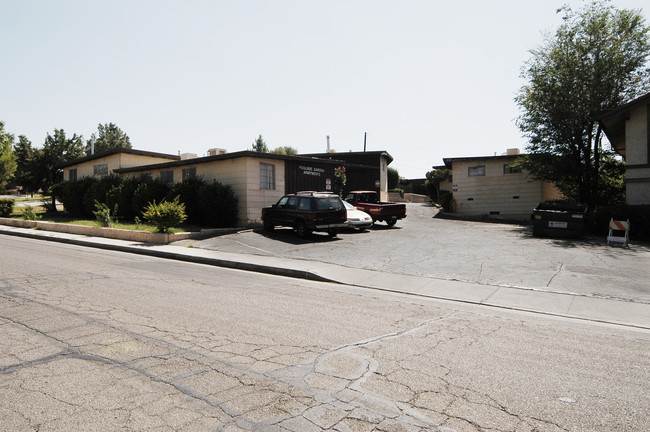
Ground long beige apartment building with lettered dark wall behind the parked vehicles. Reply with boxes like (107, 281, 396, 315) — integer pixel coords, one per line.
(61, 149, 392, 226)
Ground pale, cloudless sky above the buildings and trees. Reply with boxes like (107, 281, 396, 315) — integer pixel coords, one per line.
(0, 0, 650, 178)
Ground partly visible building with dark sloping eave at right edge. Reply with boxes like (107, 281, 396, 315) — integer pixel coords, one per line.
(599, 93, 650, 205)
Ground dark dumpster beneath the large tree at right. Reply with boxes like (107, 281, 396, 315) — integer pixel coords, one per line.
(531, 201, 587, 237)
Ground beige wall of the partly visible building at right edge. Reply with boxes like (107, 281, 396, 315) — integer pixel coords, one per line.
(625, 105, 650, 205)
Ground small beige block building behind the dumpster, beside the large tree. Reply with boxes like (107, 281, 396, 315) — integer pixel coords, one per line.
(441, 149, 561, 220)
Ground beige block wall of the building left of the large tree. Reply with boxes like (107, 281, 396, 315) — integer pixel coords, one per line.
(452, 158, 540, 220)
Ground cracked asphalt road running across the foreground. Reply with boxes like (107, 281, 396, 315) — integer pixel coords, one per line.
(0, 236, 650, 432)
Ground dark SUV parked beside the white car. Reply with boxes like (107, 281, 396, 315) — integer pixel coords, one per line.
(262, 192, 348, 238)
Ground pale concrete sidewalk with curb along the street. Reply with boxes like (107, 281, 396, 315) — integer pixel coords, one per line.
(0, 225, 650, 330)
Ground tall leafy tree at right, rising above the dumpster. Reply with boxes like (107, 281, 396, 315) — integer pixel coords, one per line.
(515, 0, 650, 208)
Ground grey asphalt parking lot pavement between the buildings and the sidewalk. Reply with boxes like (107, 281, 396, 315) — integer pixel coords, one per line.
(192, 204, 650, 303)
